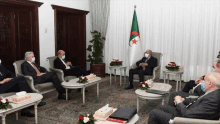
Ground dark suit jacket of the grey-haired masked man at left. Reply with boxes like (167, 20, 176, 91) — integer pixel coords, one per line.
(21, 61, 48, 78)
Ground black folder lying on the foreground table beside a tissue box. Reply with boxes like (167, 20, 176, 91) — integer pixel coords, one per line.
(109, 108, 137, 122)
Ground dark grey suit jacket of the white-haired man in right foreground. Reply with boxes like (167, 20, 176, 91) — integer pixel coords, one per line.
(176, 89, 220, 120)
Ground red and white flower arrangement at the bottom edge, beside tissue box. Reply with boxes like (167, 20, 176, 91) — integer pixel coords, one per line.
(77, 114, 96, 124)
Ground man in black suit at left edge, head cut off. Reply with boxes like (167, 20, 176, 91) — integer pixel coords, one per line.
(0, 63, 41, 117)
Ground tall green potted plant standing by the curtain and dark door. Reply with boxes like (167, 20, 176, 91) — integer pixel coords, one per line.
(87, 30, 105, 77)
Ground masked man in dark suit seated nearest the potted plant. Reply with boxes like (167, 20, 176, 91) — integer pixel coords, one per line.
(54, 50, 86, 77)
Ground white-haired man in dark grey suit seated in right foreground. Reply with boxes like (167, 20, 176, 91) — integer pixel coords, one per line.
(148, 72, 220, 124)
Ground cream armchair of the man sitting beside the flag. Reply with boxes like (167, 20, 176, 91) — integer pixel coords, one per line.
(133, 52, 163, 82)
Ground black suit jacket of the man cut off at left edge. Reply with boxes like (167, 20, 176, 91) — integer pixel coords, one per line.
(0, 64, 15, 81)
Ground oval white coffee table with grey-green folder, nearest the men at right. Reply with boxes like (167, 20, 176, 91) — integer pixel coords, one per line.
(135, 82, 172, 111)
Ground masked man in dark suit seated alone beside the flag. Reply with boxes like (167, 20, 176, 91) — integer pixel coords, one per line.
(126, 50, 157, 89)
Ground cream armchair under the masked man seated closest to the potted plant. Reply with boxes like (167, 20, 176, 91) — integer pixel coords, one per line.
(47, 56, 76, 82)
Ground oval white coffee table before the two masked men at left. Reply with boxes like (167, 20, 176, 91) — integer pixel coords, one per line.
(62, 77, 101, 105)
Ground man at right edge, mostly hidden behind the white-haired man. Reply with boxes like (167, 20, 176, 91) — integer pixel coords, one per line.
(182, 60, 220, 93)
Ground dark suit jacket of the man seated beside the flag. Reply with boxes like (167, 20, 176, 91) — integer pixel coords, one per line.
(136, 56, 157, 72)
